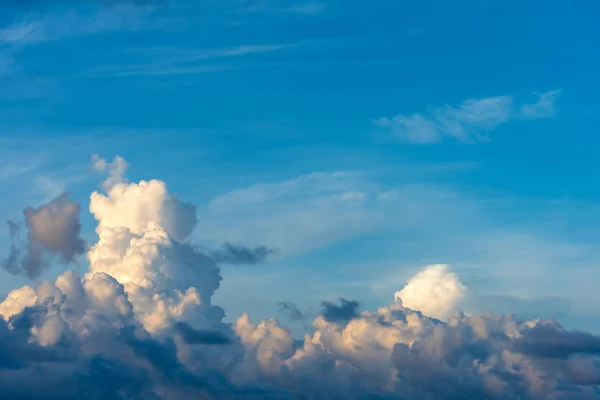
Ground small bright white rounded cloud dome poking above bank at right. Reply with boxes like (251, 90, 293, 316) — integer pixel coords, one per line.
(395, 265, 466, 319)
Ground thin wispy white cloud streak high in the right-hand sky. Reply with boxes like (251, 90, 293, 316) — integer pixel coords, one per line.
(374, 90, 560, 144)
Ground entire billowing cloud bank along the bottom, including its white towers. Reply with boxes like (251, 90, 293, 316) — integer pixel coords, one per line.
(0, 158, 600, 400)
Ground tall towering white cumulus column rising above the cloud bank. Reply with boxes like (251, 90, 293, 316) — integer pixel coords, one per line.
(88, 173, 223, 333)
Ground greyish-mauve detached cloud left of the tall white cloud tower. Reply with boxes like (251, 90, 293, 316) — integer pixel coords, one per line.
(3, 193, 86, 279)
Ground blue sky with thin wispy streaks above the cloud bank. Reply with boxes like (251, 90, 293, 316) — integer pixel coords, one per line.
(0, 0, 600, 331)
